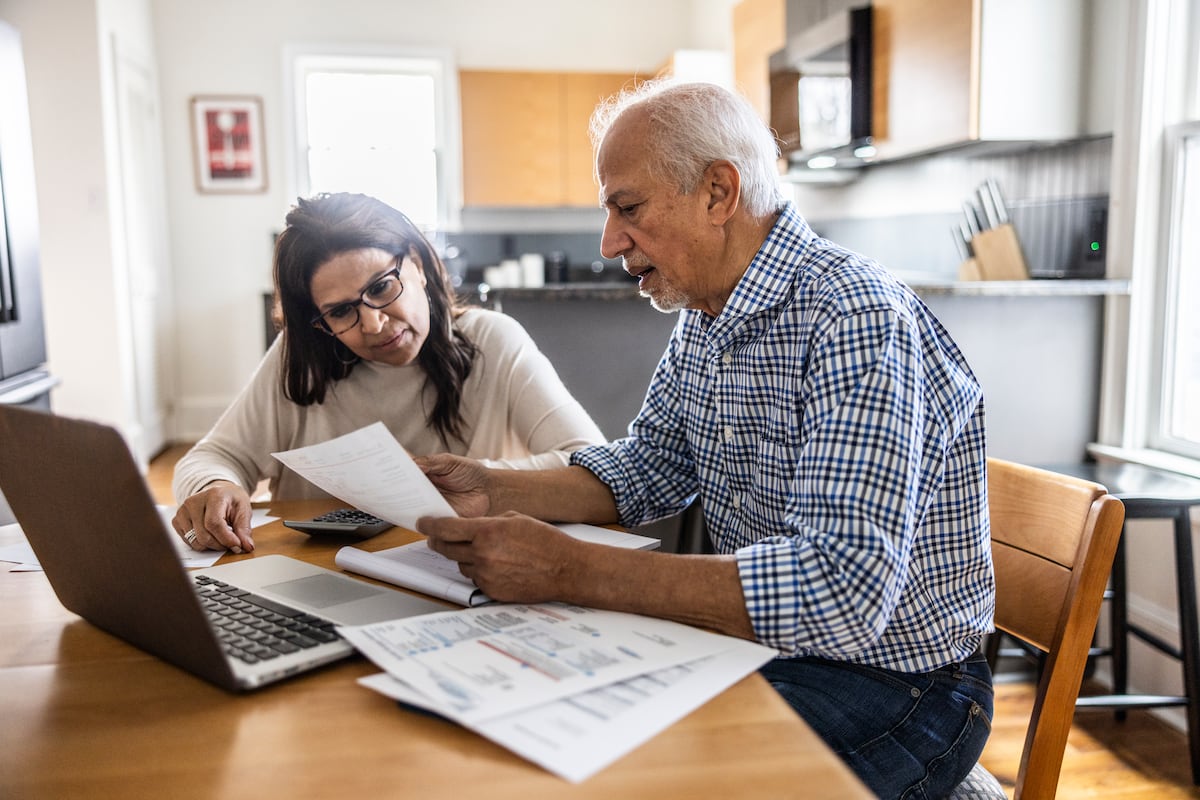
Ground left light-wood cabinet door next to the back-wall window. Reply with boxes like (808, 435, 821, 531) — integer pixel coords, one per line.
(458, 71, 564, 206)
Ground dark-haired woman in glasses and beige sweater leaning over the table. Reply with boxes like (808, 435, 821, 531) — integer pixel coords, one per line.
(173, 194, 604, 552)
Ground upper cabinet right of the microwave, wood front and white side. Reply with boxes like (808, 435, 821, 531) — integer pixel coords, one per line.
(872, 0, 1090, 160)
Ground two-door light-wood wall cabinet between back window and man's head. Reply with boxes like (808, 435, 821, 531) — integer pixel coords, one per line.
(458, 70, 634, 207)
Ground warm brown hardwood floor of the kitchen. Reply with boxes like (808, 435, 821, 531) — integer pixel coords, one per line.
(146, 445, 1200, 800)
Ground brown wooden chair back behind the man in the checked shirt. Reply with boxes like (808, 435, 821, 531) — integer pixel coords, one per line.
(988, 458, 1124, 800)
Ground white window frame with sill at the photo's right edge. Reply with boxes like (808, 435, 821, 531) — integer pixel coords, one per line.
(1088, 0, 1200, 477)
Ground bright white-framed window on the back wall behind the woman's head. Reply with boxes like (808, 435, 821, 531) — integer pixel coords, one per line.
(288, 49, 461, 231)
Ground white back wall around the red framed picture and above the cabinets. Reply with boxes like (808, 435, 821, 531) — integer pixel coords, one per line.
(150, 0, 733, 438)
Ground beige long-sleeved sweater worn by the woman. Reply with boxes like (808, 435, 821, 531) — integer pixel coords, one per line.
(173, 308, 604, 500)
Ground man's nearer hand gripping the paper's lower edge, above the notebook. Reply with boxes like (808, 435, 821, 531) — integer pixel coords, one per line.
(416, 512, 582, 603)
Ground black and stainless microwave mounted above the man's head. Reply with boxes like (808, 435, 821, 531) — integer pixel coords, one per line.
(769, 6, 874, 166)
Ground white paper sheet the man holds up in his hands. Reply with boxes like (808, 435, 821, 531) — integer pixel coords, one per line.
(271, 422, 457, 530)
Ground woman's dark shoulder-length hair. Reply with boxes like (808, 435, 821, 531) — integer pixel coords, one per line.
(274, 193, 476, 443)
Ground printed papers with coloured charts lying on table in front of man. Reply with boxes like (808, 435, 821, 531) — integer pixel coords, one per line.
(338, 603, 776, 782)
